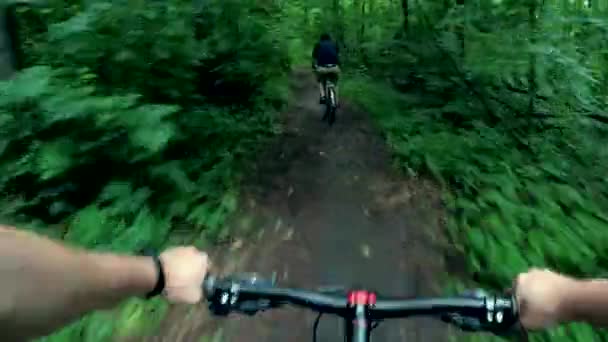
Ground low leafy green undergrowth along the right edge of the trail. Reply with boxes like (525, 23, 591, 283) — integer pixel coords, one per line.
(343, 70, 608, 341)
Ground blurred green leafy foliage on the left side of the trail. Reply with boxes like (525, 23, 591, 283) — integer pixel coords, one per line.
(0, 0, 289, 341)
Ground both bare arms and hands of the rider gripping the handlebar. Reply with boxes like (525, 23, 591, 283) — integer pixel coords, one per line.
(0, 225, 608, 341)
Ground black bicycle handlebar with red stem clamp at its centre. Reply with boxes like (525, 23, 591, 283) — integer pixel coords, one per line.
(203, 275, 518, 341)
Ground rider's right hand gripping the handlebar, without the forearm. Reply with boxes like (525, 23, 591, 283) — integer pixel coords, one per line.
(514, 269, 578, 330)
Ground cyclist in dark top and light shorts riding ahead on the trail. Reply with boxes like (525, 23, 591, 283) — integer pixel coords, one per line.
(312, 33, 340, 104)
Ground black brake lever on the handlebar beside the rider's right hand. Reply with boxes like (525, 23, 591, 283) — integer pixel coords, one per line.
(440, 289, 524, 337)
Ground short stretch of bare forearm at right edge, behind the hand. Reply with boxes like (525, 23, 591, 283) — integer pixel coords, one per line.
(561, 279, 608, 326)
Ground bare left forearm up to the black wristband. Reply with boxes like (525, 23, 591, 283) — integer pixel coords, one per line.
(0, 227, 157, 340)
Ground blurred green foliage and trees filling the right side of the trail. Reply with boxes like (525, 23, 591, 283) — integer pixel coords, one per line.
(343, 2, 608, 334)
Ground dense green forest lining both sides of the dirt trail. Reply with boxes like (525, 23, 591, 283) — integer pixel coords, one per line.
(0, 0, 608, 341)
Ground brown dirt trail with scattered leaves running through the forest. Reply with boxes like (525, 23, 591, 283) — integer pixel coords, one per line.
(149, 71, 456, 342)
